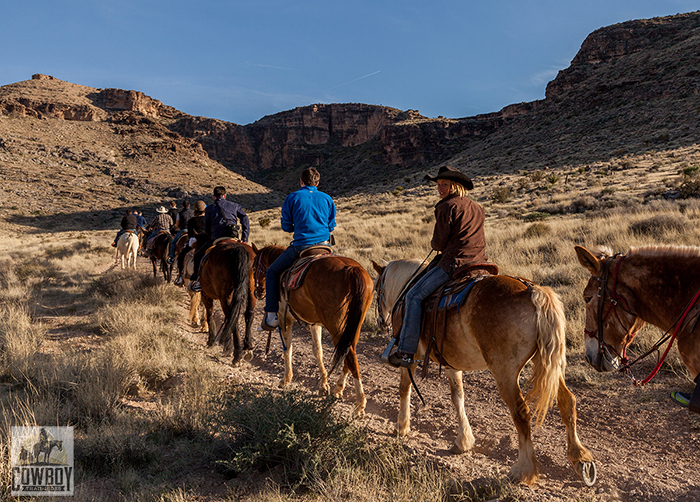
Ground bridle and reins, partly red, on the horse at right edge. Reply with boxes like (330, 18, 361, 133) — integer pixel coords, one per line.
(584, 253, 700, 385)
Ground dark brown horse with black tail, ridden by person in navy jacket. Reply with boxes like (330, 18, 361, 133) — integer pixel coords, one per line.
(199, 239, 256, 366)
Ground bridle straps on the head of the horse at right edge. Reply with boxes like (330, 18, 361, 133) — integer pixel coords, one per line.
(583, 253, 639, 370)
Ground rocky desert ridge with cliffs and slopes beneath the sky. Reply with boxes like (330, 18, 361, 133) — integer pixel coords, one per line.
(0, 12, 700, 218)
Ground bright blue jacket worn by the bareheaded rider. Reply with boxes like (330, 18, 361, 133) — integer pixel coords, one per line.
(282, 186, 336, 246)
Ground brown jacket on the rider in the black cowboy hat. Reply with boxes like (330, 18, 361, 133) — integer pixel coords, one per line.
(430, 194, 487, 275)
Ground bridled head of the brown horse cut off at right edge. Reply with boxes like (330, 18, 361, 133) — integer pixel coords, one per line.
(575, 246, 645, 372)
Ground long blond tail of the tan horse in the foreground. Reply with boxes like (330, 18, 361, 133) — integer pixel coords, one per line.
(526, 284, 566, 427)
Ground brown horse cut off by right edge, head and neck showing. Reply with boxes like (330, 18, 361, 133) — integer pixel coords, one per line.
(575, 246, 700, 383)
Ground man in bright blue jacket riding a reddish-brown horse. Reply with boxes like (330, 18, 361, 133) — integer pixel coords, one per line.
(262, 167, 336, 331)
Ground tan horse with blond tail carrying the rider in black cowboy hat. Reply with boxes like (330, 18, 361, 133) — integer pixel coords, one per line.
(372, 260, 595, 486)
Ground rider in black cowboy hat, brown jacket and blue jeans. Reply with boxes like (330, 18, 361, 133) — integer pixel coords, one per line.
(389, 166, 487, 368)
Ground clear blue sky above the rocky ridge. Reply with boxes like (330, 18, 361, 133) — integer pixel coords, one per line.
(0, 0, 700, 124)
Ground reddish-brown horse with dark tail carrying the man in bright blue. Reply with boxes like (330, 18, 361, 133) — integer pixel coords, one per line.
(255, 246, 372, 417)
